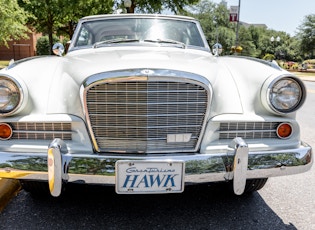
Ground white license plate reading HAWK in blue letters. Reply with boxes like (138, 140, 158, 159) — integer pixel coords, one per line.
(115, 160, 185, 194)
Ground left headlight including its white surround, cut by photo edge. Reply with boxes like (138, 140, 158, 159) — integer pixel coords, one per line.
(0, 74, 28, 116)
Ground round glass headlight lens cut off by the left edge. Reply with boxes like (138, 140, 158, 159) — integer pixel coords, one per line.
(0, 76, 22, 115)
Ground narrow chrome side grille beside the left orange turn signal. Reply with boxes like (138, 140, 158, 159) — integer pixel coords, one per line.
(10, 122, 72, 140)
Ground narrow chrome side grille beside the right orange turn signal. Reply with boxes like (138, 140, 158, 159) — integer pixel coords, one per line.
(219, 122, 281, 139)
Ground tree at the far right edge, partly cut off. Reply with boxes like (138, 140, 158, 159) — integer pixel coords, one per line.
(297, 14, 315, 58)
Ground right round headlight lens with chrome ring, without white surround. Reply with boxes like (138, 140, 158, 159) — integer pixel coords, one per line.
(267, 77, 305, 113)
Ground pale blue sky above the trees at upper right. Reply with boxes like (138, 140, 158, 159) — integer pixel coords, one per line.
(212, 0, 315, 36)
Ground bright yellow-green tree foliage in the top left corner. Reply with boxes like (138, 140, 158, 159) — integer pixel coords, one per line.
(0, 0, 29, 46)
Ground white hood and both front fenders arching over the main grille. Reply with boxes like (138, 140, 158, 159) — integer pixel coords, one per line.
(4, 46, 281, 117)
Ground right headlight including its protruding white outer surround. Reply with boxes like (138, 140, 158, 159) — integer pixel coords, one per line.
(261, 75, 306, 115)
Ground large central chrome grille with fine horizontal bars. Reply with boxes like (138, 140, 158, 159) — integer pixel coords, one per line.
(86, 81, 208, 153)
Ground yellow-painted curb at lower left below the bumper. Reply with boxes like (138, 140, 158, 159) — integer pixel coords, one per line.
(0, 178, 21, 212)
